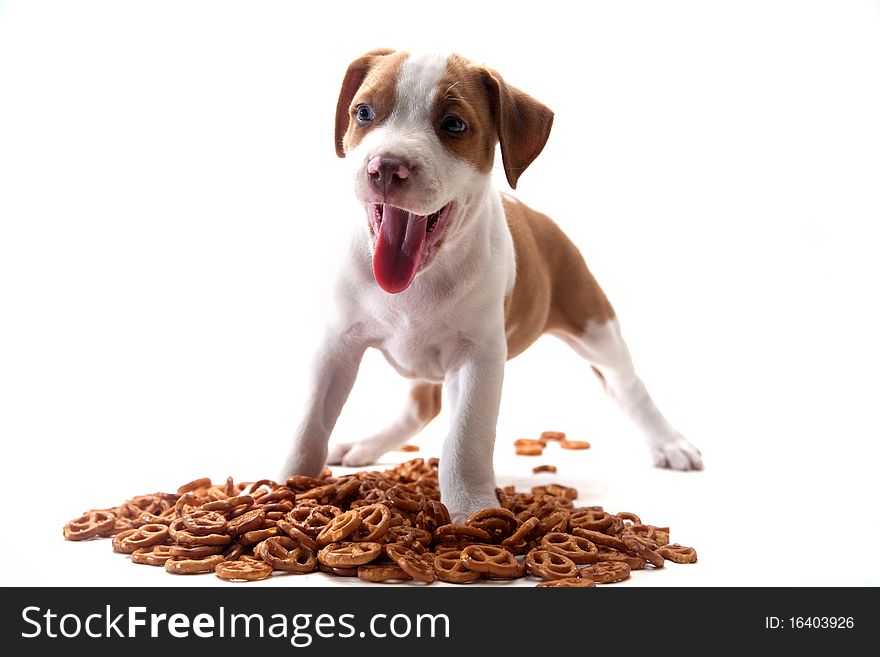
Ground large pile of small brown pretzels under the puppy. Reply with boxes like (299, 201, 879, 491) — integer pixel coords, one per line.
(64, 458, 697, 587)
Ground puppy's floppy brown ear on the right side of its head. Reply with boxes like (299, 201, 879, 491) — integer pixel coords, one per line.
(483, 69, 553, 189)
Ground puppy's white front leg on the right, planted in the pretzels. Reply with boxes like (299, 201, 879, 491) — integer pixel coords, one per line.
(440, 332, 507, 522)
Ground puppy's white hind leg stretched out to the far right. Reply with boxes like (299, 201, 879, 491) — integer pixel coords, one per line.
(553, 317, 703, 470)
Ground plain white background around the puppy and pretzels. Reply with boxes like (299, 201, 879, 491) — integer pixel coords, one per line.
(0, 0, 880, 586)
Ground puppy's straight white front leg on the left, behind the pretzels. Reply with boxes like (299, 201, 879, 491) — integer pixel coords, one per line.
(282, 333, 366, 478)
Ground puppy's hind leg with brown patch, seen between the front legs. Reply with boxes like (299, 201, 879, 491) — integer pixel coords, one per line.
(327, 381, 443, 467)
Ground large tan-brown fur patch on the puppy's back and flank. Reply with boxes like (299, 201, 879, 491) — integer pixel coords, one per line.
(501, 194, 614, 359)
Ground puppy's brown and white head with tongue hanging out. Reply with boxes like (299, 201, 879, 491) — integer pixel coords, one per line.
(336, 50, 553, 293)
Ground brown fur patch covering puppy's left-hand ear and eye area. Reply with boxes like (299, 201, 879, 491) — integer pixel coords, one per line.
(336, 48, 408, 157)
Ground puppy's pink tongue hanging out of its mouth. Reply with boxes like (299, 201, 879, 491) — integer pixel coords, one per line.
(373, 205, 428, 294)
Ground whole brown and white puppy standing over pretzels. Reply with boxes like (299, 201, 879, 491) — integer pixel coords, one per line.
(283, 50, 702, 519)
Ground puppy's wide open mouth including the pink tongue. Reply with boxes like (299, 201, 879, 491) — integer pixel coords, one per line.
(367, 203, 452, 294)
